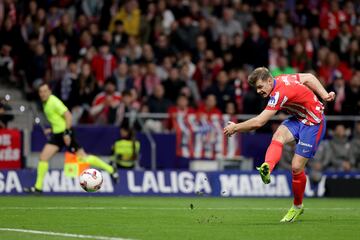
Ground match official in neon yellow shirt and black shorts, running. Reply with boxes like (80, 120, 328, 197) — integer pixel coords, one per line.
(24, 83, 119, 193)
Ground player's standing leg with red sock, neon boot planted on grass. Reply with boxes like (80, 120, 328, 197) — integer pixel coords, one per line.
(280, 154, 309, 222)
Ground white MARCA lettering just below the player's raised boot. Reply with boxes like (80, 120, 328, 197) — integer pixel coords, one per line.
(219, 174, 291, 197)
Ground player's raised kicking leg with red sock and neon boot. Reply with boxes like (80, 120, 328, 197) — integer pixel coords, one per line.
(256, 124, 295, 184)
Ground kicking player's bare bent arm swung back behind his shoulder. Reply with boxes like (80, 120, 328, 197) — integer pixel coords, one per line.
(299, 73, 335, 102)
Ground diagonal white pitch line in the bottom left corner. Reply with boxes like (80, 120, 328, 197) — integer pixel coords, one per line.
(0, 228, 135, 240)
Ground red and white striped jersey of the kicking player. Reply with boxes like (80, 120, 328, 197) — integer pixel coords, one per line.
(265, 74, 324, 125)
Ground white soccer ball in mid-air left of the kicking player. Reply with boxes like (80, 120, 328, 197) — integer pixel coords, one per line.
(80, 168, 103, 192)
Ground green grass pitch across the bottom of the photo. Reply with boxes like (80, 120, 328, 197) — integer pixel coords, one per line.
(0, 196, 360, 240)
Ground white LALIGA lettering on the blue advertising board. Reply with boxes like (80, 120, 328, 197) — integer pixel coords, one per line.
(127, 171, 211, 194)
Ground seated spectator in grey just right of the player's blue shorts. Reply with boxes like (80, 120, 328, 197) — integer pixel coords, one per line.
(314, 124, 352, 171)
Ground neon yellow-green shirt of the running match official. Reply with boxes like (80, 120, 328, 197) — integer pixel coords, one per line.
(43, 95, 68, 134)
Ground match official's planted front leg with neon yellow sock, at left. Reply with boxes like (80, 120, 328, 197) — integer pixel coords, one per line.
(24, 143, 59, 193)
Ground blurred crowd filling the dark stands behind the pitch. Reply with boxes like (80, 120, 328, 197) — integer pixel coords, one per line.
(0, 0, 360, 167)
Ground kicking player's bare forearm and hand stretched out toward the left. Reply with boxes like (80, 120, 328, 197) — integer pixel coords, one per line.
(224, 109, 277, 137)
